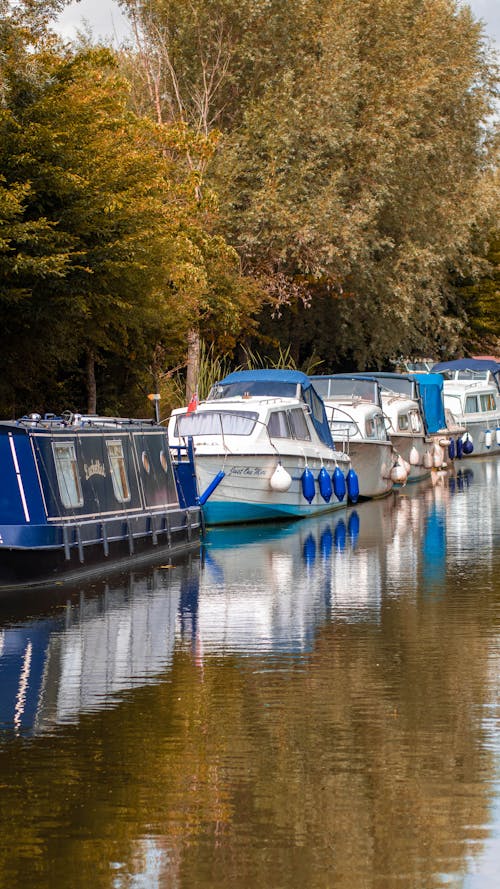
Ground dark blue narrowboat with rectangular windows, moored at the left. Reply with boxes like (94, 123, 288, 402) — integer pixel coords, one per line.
(0, 412, 201, 589)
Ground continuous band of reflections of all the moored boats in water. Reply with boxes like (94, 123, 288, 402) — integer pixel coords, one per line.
(0, 459, 500, 733)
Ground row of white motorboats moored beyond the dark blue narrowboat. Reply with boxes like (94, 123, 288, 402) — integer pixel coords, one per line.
(169, 365, 500, 525)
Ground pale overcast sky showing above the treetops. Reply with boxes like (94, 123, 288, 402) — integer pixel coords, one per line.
(54, 0, 500, 47)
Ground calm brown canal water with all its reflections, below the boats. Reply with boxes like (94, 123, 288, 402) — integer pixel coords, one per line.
(0, 458, 500, 889)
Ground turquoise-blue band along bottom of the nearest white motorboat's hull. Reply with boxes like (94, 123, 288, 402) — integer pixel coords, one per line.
(203, 501, 347, 525)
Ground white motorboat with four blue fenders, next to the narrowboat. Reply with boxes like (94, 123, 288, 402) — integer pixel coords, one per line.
(168, 370, 359, 525)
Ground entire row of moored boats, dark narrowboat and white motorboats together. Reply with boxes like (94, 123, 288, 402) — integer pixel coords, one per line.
(0, 359, 500, 589)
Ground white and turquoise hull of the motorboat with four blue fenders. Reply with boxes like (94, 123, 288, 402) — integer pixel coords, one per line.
(196, 453, 350, 525)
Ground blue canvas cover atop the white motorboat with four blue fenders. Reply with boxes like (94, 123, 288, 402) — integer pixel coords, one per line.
(213, 368, 335, 449)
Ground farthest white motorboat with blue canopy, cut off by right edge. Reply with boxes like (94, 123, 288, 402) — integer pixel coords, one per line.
(432, 358, 500, 457)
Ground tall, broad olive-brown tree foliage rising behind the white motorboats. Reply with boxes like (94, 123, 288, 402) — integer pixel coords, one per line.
(122, 0, 498, 366)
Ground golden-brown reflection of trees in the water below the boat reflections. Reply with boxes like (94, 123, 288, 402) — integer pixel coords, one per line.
(0, 560, 492, 889)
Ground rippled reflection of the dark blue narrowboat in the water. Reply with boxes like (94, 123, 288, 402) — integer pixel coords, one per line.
(0, 555, 199, 734)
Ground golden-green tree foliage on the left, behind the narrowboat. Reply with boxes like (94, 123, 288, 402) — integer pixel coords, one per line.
(0, 0, 252, 413)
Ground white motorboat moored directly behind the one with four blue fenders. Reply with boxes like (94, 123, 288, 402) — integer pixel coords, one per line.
(311, 374, 398, 498)
